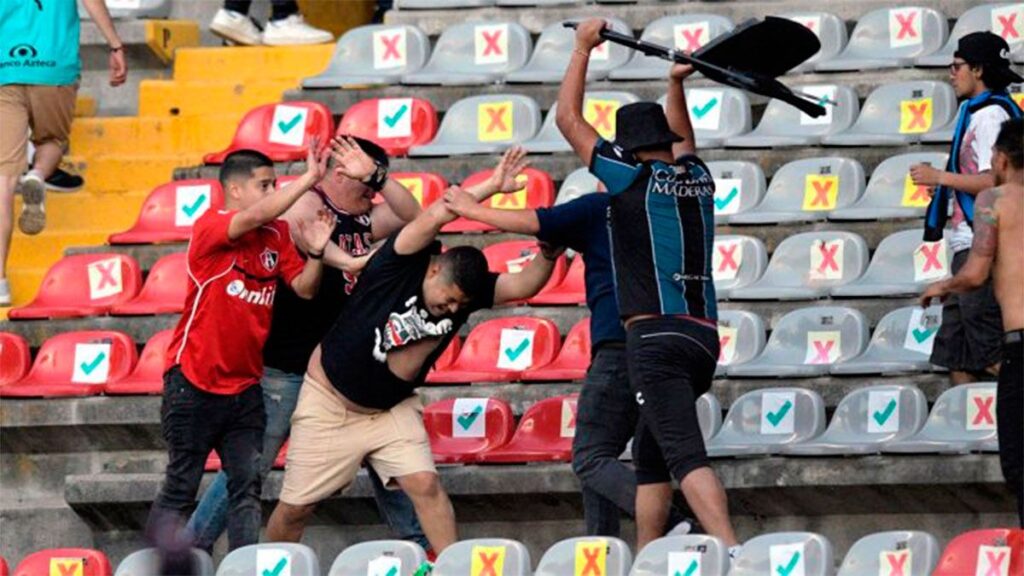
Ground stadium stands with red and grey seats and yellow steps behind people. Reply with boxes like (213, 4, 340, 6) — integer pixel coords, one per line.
(0, 0, 1024, 576)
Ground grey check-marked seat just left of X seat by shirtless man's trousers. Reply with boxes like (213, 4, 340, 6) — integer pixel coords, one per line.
(782, 384, 928, 456)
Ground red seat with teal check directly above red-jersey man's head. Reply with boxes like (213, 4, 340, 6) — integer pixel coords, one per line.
(203, 101, 334, 164)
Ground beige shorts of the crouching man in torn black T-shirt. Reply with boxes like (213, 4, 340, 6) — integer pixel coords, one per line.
(281, 374, 436, 505)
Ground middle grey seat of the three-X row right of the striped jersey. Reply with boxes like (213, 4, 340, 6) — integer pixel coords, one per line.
(729, 231, 867, 300)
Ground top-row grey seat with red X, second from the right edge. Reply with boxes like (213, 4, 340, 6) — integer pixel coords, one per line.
(815, 6, 949, 72)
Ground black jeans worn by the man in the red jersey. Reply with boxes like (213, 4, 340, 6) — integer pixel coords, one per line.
(146, 366, 266, 550)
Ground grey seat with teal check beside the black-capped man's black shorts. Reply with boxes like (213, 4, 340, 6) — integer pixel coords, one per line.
(831, 306, 942, 376)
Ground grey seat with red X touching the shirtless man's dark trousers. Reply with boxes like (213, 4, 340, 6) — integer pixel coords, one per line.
(883, 382, 996, 454)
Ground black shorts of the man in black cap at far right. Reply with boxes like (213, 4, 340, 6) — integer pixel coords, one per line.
(931, 250, 1002, 372)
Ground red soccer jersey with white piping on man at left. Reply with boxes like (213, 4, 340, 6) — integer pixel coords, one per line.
(167, 210, 304, 395)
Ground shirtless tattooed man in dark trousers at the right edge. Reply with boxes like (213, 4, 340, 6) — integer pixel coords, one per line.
(921, 118, 1024, 525)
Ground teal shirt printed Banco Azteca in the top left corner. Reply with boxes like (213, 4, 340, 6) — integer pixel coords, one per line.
(0, 0, 82, 86)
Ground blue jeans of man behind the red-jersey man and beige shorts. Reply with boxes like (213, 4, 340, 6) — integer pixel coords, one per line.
(188, 368, 430, 551)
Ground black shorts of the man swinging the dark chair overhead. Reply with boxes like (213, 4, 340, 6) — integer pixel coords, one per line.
(627, 317, 719, 484)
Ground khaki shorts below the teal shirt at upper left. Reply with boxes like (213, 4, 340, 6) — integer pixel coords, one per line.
(0, 84, 78, 176)
